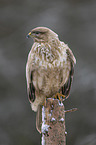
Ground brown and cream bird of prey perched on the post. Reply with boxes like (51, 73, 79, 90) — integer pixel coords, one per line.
(26, 27, 76, 132)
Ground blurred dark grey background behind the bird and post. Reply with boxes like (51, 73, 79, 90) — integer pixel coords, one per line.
(0, 0, 96, 145)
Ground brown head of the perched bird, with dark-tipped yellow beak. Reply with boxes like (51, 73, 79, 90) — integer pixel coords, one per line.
(27, 27, 58, 42)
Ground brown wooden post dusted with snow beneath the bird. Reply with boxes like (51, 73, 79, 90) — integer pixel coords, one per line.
(41, 98, 66, 145)
